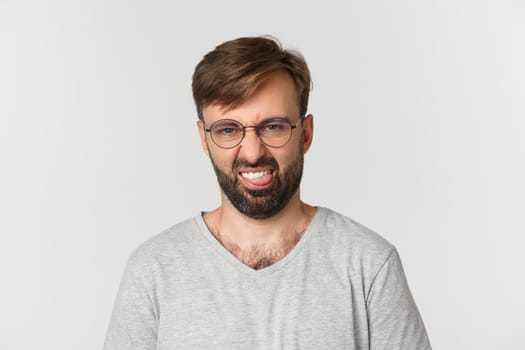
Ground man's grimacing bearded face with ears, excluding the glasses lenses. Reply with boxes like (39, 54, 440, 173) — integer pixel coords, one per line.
(198, 72, 313, 219)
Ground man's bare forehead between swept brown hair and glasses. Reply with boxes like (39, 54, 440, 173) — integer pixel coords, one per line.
(203, 71, 299, 123)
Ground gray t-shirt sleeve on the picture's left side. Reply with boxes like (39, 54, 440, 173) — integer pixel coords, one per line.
(104, 255, 158, 350)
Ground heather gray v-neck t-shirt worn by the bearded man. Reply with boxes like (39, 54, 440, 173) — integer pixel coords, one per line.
(104, 208, 430, 350)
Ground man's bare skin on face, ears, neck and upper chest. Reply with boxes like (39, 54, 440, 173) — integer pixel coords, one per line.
(197, 72, 316, 269)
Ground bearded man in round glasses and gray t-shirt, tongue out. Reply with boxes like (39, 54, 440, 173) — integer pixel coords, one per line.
(105, 37, 430, 350)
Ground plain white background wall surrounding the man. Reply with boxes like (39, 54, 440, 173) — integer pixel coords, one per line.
(0, 0, 525, 350)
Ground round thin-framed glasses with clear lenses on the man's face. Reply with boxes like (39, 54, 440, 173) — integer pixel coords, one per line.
(204, 117, 304, 149)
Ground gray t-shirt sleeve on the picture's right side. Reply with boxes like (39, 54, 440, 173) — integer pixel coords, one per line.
(367, 249, 431, 350)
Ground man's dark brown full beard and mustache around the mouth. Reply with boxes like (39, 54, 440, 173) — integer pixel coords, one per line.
(210, 152, 304, 219)
